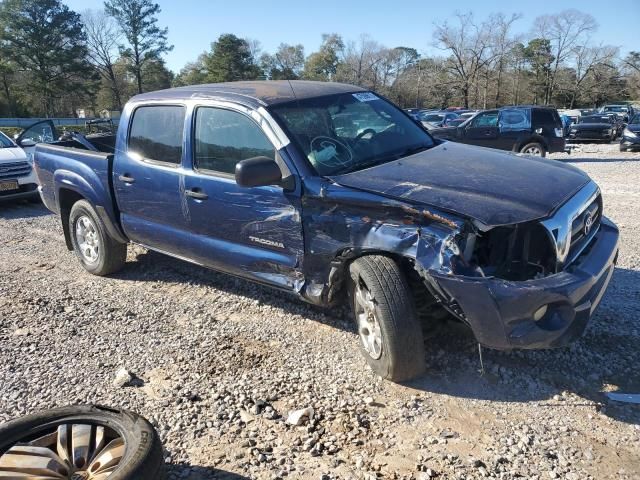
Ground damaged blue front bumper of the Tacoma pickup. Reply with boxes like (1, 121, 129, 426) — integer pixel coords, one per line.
(430, 217, 619, 350)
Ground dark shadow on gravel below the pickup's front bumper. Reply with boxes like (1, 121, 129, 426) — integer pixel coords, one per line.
(407, 268, 640, 424)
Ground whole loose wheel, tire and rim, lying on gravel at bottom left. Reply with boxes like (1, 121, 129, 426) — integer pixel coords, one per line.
(0, 406, 164, 480)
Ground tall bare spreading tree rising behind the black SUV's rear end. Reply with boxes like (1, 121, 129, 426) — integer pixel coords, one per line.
(533, 9, 598, 104)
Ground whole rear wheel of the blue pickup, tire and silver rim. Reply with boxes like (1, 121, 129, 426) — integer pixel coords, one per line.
(69, 200, 127, 275)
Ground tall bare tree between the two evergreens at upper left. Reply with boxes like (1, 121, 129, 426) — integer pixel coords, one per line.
(82, 10, 122, 110)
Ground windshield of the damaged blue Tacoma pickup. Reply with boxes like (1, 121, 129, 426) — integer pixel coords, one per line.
(271, 92, 434, 175)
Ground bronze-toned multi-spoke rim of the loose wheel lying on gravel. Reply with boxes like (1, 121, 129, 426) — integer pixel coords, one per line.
(0, 424, 125, 480)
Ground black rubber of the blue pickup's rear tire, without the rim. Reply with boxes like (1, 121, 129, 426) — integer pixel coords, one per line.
(69, 200, 127, 276)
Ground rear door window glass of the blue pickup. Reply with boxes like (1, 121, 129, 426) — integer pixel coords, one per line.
(129, 105, 185, 165)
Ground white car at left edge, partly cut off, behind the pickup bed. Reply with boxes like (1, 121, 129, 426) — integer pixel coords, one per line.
(0, 132, 40, 201)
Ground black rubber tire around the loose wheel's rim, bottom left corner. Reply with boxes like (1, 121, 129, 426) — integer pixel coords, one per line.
(0, 405, 165, 480)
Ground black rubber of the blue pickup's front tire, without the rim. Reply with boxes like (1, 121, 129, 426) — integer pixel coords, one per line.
(349, 255, 426, 382)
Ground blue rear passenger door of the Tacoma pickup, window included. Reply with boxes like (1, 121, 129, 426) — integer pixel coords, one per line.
(113, 104, 189, 255)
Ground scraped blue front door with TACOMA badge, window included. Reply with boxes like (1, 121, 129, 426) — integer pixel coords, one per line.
(185, 106, 304, 290)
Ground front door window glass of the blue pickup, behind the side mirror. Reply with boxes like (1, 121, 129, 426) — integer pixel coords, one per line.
(194, 107, 275, 174)
